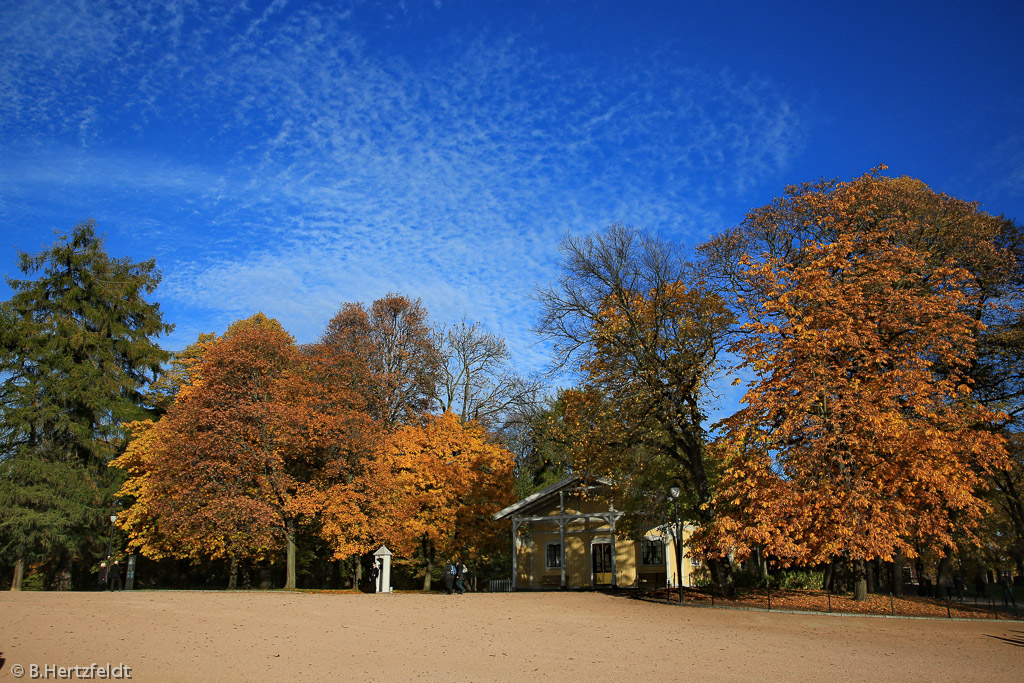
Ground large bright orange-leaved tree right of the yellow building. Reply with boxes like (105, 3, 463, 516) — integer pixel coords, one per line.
(716, 174, 1006, 599)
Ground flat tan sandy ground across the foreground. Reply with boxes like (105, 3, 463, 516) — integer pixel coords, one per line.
(0, 591, 1024, 683)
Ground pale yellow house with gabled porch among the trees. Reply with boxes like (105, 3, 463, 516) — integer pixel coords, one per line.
(495, 476, 699, 590)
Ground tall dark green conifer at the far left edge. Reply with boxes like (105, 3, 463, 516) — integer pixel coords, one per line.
(0, 221, 173, 589)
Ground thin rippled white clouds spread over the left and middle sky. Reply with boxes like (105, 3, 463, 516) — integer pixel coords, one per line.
(0, 0, 802, 368)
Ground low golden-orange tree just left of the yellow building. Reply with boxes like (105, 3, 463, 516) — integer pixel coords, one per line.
(324, 412, 514, 590)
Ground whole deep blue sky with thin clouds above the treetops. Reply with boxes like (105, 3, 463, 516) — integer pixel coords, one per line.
(0, 0, 1024, 411)
